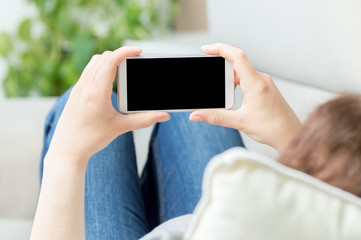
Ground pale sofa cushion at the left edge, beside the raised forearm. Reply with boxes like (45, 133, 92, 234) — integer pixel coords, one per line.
(0, 98, 55, 219)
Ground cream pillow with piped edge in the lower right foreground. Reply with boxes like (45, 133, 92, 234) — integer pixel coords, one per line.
(186, 148, 361, 240)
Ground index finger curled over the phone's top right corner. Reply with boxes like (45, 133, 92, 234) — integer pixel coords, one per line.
(202, 43, 258, 90)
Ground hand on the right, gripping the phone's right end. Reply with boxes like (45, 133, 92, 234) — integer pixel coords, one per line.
(190, 43, 302, 151)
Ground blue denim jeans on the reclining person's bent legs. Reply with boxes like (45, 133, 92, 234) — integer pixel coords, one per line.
(40, 90, 244, 240)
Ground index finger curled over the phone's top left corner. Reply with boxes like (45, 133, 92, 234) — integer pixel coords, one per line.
(95, 47, 142, 90)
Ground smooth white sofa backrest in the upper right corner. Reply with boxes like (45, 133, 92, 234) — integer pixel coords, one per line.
(207, 0, 361, 93)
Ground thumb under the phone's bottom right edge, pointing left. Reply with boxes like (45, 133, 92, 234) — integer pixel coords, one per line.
(189, 109, 241, 129)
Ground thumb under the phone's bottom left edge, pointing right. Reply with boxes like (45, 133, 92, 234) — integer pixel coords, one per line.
(119, 112, 170, 132)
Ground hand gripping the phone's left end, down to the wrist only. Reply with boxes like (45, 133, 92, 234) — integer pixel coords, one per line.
(48, 47, 170, 166)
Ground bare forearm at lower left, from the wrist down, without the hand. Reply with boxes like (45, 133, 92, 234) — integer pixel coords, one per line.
(31, 154, 86, 240)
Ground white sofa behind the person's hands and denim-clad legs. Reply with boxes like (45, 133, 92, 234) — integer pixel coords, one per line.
(0, 0, 361, 239)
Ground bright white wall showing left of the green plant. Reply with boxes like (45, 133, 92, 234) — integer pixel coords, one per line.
(0, 0, 35, 98)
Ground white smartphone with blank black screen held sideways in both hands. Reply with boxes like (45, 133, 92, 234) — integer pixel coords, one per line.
(118, 55, 234, 113)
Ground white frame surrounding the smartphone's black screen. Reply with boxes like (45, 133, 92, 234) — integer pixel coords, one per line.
(117, 55, 234, 113)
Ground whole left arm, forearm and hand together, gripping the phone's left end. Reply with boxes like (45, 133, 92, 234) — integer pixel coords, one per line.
(31, 47, 170, 240)
